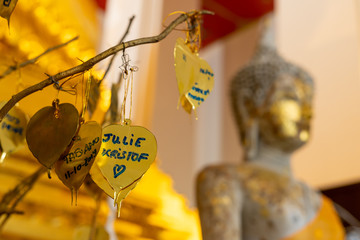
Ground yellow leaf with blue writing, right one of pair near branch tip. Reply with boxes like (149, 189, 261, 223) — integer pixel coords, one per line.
(183, 58, 214, 112)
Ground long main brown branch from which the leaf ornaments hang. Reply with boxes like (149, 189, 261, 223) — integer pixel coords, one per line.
(0, 10, 214, 122)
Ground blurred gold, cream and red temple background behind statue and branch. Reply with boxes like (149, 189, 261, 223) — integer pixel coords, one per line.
(0, 0, 360, 240)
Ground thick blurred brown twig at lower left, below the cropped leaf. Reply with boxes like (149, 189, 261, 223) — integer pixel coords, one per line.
(0, 167, 47, 232)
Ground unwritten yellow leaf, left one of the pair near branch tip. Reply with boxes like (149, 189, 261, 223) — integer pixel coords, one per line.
(174, 38, 200, 98)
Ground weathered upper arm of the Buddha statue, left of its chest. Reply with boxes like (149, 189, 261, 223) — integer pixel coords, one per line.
(196, 167, 243, 240)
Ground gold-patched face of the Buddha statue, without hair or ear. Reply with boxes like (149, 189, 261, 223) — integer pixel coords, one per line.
(258, 74, 312, 152)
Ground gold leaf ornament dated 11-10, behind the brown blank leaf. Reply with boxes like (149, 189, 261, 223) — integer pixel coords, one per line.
(54, 121, 102, 203)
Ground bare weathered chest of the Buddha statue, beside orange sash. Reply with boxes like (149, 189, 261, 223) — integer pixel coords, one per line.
(238, 165, 321, 240)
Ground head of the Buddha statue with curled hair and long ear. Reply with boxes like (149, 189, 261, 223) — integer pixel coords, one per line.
(231, 48, 313, 159)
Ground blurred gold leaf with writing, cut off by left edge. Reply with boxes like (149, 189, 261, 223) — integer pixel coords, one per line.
(0, 102, 28, 156)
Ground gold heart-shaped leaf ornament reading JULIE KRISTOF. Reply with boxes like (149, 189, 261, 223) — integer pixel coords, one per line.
(90, 124, 157, 215)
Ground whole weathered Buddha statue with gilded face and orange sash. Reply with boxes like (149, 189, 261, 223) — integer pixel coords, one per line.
(196, 17, 345, 240)
